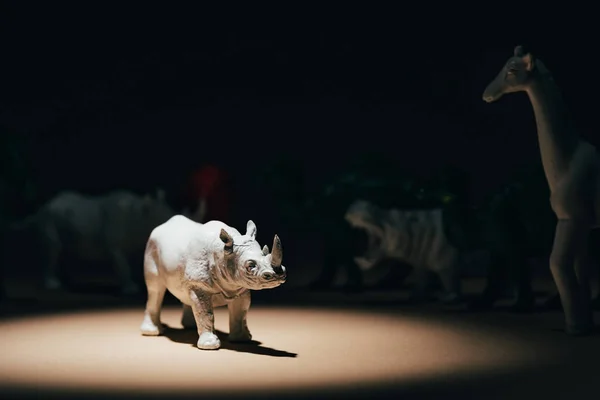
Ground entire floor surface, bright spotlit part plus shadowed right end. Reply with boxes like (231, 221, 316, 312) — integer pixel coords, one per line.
(0, 292, 600, 399)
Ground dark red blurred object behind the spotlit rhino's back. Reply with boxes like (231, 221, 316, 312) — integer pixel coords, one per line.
(186, 165, 230, 223)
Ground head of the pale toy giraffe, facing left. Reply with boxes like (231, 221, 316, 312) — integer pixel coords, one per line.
(483, 46, 535, 103)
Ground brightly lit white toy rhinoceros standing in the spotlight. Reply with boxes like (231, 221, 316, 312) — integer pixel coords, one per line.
(140, 215, 286, 350)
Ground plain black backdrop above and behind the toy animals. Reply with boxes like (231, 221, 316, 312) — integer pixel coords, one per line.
(0, 1, 599, 238)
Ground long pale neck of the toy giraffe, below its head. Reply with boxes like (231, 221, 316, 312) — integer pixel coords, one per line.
(527, 60, 579, 190)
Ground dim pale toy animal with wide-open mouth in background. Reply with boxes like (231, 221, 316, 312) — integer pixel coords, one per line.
(345, 200, 460, 302)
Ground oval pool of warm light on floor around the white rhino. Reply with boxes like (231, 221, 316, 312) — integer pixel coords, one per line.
(0, 306, 543, 396)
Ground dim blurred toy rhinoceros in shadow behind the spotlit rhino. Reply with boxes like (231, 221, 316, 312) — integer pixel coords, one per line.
(12, 190, 175, 294)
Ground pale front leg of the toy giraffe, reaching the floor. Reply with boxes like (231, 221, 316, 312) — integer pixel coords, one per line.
(550, 220, 593, 335)
